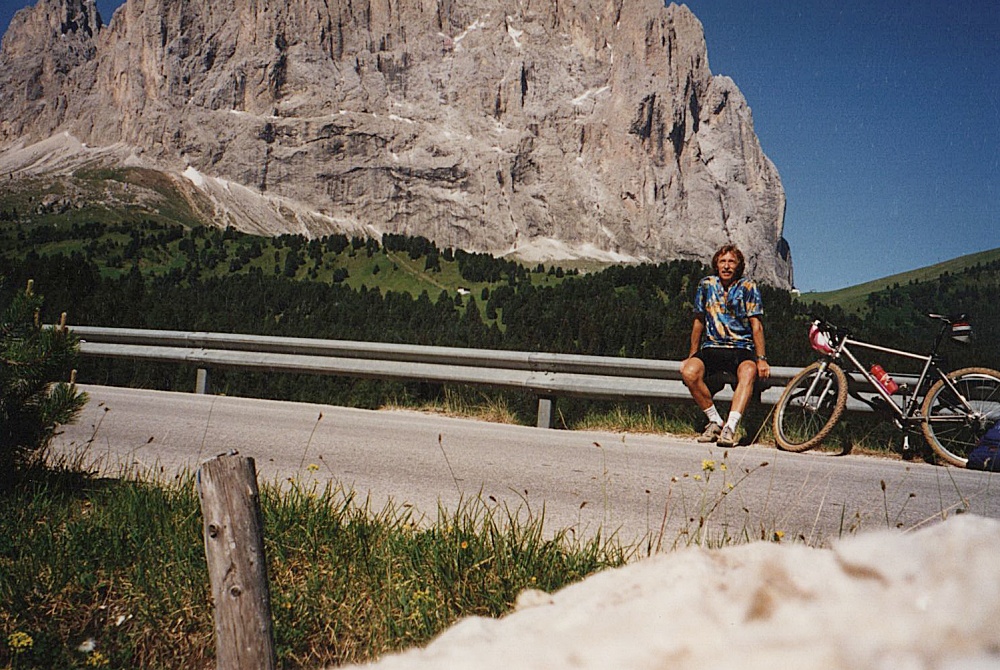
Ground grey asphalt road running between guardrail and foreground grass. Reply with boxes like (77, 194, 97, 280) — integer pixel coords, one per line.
(53, 386, 1000, 546)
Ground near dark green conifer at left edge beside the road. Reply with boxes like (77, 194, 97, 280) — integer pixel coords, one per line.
(0, 281, 87, 490)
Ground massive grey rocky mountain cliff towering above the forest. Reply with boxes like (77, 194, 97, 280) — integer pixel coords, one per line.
(0, 0, 792, 287)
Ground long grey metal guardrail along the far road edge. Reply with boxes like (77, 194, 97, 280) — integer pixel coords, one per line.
(71, 326, 866, 427)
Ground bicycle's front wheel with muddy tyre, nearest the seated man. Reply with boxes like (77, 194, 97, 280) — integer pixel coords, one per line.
(774, 362, 847, 451)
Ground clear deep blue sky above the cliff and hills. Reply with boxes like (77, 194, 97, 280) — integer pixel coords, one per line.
(0, 0, 1000, 291)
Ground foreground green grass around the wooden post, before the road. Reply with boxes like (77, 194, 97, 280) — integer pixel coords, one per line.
(0, 460, 632, 668)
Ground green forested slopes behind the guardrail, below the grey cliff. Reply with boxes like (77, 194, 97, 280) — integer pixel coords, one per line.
(0, 217, 1000, 440)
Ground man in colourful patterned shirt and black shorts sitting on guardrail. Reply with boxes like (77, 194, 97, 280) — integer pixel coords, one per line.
(681, 244, 771, 447)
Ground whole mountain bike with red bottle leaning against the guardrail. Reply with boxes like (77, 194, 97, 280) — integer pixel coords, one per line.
(773, 314, 1000, 467)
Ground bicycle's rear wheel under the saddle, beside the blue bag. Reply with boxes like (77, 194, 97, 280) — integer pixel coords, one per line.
(923, 368, 1000, 468)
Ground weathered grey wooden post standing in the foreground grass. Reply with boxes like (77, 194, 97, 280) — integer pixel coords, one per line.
(197, 452, 277, 670)
